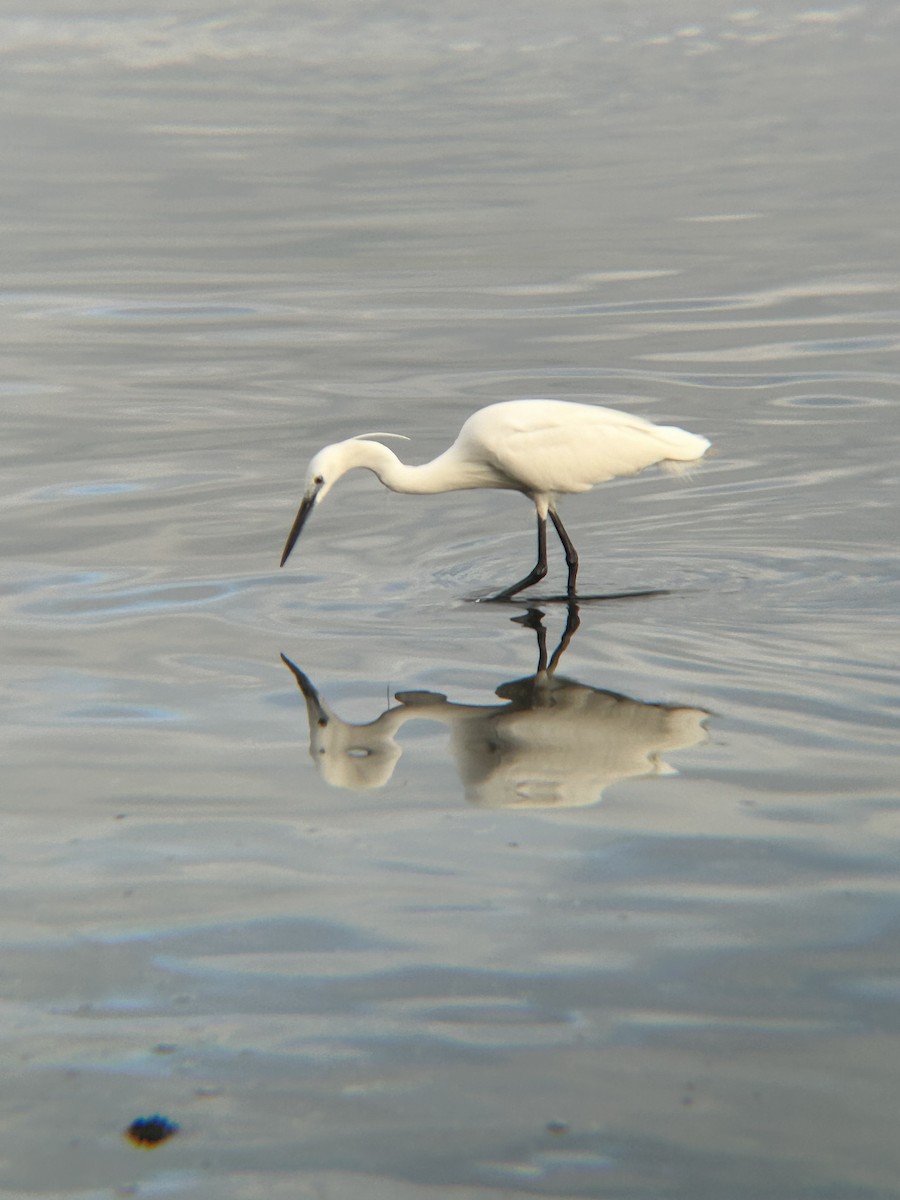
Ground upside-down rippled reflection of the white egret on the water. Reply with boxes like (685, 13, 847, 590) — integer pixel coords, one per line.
(282, 604, 709, 809)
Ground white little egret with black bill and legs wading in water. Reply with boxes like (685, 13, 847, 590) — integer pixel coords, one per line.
(281, 400, 709, 600)
